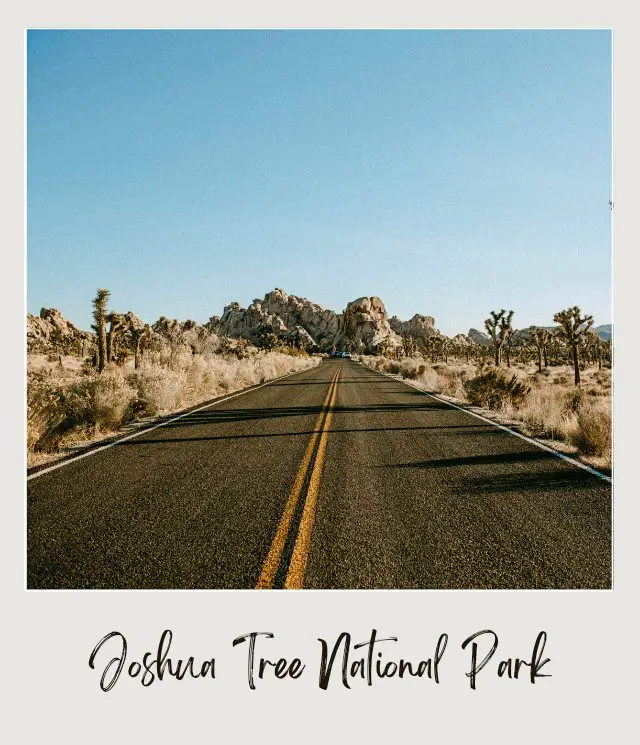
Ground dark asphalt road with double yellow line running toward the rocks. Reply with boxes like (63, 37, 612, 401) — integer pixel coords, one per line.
(27, 360, 612, 589)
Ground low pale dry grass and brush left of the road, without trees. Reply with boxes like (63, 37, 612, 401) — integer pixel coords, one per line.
(27, 346, 320, 466)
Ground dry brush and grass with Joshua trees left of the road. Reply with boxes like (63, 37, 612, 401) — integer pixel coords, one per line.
(27, 290, 320, 467)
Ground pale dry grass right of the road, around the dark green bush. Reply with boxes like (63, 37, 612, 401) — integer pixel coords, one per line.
(360, 356, 612, 468)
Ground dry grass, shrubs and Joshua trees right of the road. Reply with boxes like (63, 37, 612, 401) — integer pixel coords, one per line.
(359, 307, 612, 469)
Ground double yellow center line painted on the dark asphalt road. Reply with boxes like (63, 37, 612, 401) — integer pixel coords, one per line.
(256, 370, 340, 589)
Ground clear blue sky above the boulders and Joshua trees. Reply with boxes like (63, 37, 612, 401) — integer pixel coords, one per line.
(27, 30, 611, 334)
